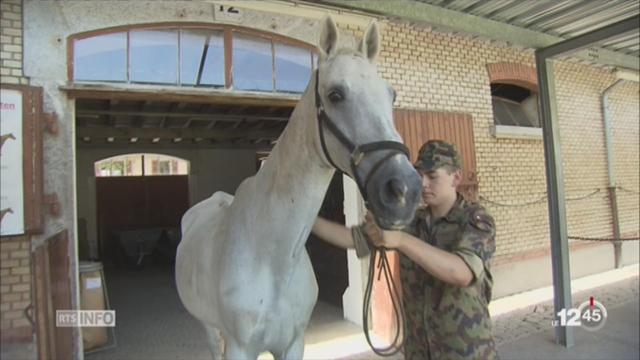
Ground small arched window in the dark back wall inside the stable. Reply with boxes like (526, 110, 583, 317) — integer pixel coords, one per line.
(94, 154, 189, 177)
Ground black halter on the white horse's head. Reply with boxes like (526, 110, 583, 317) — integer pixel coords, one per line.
(316, 69, 409, 204)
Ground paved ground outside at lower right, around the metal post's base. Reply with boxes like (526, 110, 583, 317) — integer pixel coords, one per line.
(493, 276, 640, 360)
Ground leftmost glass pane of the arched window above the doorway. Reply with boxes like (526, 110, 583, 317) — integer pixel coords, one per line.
(73, 33, 127, 81)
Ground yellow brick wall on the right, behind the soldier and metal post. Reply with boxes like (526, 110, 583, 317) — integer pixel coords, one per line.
(341, 21, 639, 259)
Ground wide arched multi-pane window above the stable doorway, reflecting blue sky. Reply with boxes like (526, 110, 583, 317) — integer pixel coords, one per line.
(70, 26, 318, 93)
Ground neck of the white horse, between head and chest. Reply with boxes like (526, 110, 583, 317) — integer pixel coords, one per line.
(255, 80, 334, 248)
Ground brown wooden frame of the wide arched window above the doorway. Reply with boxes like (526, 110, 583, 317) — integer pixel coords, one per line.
(67, 22, 318, 94)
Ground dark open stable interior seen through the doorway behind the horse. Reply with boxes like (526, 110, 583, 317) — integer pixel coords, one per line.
(76, 96, 361, 359)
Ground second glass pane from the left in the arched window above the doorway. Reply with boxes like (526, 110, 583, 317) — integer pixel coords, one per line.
(129, 29, 178, 84)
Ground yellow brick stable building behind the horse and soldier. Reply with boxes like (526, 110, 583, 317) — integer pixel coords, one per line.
(0, 0, 640, 358)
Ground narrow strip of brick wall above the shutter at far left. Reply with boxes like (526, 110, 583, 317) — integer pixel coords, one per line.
(0, 0, 28, 84)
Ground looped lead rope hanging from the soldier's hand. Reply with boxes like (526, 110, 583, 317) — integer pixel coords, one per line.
(362, 247, 406, 356)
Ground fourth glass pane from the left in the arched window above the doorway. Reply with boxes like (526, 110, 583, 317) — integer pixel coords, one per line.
(233, 34, 273, 91)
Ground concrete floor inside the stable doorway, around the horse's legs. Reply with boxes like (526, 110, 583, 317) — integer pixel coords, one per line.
(85, 267, 392, 360)
